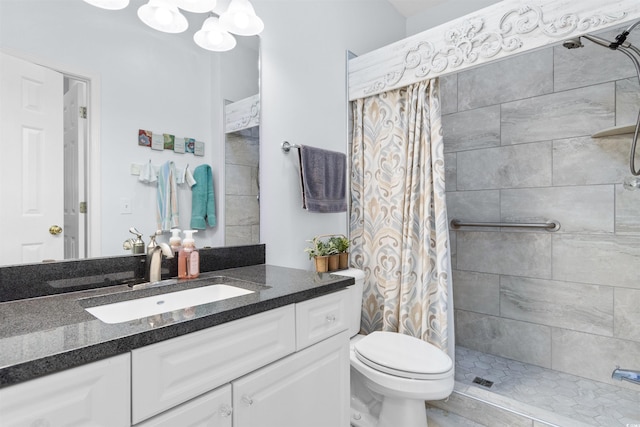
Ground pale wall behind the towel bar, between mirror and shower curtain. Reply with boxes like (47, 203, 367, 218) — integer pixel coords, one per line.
(254, 0, 405, 269)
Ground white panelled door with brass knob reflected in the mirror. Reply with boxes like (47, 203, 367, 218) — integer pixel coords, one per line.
(0, 53, 64, 265)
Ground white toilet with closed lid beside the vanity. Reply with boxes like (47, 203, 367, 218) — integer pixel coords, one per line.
(333, 269, 454, 427)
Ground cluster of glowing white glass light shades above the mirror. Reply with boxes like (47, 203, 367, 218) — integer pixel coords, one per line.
(84, 0, 264, 52)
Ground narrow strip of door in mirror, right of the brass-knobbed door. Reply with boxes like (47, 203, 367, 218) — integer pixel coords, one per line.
(63, 81, 87, 259)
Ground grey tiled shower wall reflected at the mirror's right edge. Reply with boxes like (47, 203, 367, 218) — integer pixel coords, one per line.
(224, 126, 260, 246)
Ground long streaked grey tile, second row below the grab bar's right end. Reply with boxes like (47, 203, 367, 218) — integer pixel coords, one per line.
(502, 276, 613, 336)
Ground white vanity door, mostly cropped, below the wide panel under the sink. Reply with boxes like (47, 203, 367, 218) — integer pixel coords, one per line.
(136, 384, 232, 427)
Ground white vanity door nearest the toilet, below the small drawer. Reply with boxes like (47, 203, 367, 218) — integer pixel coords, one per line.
(232, 331, 349, 427)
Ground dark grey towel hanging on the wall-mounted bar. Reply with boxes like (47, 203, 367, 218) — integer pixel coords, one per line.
(298, 145, 347, 213)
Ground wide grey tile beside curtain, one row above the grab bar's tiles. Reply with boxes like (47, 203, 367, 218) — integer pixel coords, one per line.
(457, 141, 552, 190)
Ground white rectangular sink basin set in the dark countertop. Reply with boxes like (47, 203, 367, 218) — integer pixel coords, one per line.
(85, 285, 253, 323)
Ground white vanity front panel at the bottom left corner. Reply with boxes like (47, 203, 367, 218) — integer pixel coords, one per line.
(0, 354, 131, 427)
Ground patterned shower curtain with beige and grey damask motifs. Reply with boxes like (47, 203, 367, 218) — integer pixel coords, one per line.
(350, 79, 453, 357)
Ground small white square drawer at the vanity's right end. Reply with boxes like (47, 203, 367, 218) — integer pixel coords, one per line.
(296, 289, 350, 350)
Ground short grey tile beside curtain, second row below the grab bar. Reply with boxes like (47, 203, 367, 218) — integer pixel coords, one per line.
(453, 270, 500, 316)
